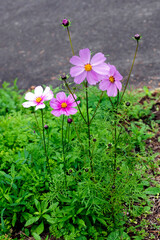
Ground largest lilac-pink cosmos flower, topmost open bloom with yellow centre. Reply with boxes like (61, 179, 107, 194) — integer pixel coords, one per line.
(70, 48, 109, 85)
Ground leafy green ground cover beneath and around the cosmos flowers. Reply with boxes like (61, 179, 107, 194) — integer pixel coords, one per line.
(0, 81, 160, 240)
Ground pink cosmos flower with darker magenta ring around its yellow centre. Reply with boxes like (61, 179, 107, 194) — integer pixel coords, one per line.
(50, 92, 80, 117)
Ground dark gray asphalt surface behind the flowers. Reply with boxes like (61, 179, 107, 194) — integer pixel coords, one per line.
(0, 0, 160, 89)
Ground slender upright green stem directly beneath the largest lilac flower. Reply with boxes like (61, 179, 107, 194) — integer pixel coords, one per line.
(86, 81, 93, 173)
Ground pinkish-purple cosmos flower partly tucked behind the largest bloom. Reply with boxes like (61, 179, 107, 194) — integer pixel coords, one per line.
(99, 64, 123, 97)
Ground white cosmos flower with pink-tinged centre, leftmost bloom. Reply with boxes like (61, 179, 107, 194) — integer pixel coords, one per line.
(22, 86, 53, 110)
